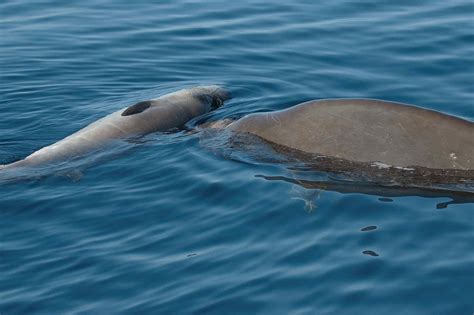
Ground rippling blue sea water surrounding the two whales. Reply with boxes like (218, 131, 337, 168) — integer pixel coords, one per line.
(0, 0, 474, 315)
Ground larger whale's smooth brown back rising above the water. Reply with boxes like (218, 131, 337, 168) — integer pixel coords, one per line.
(227, 99, 474, 170)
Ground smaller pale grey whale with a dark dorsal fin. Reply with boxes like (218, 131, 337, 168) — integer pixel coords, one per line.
(0, 85, 230, 170)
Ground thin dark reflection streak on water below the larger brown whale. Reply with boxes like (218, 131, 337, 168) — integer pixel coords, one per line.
(256, 175, 474, 209)
